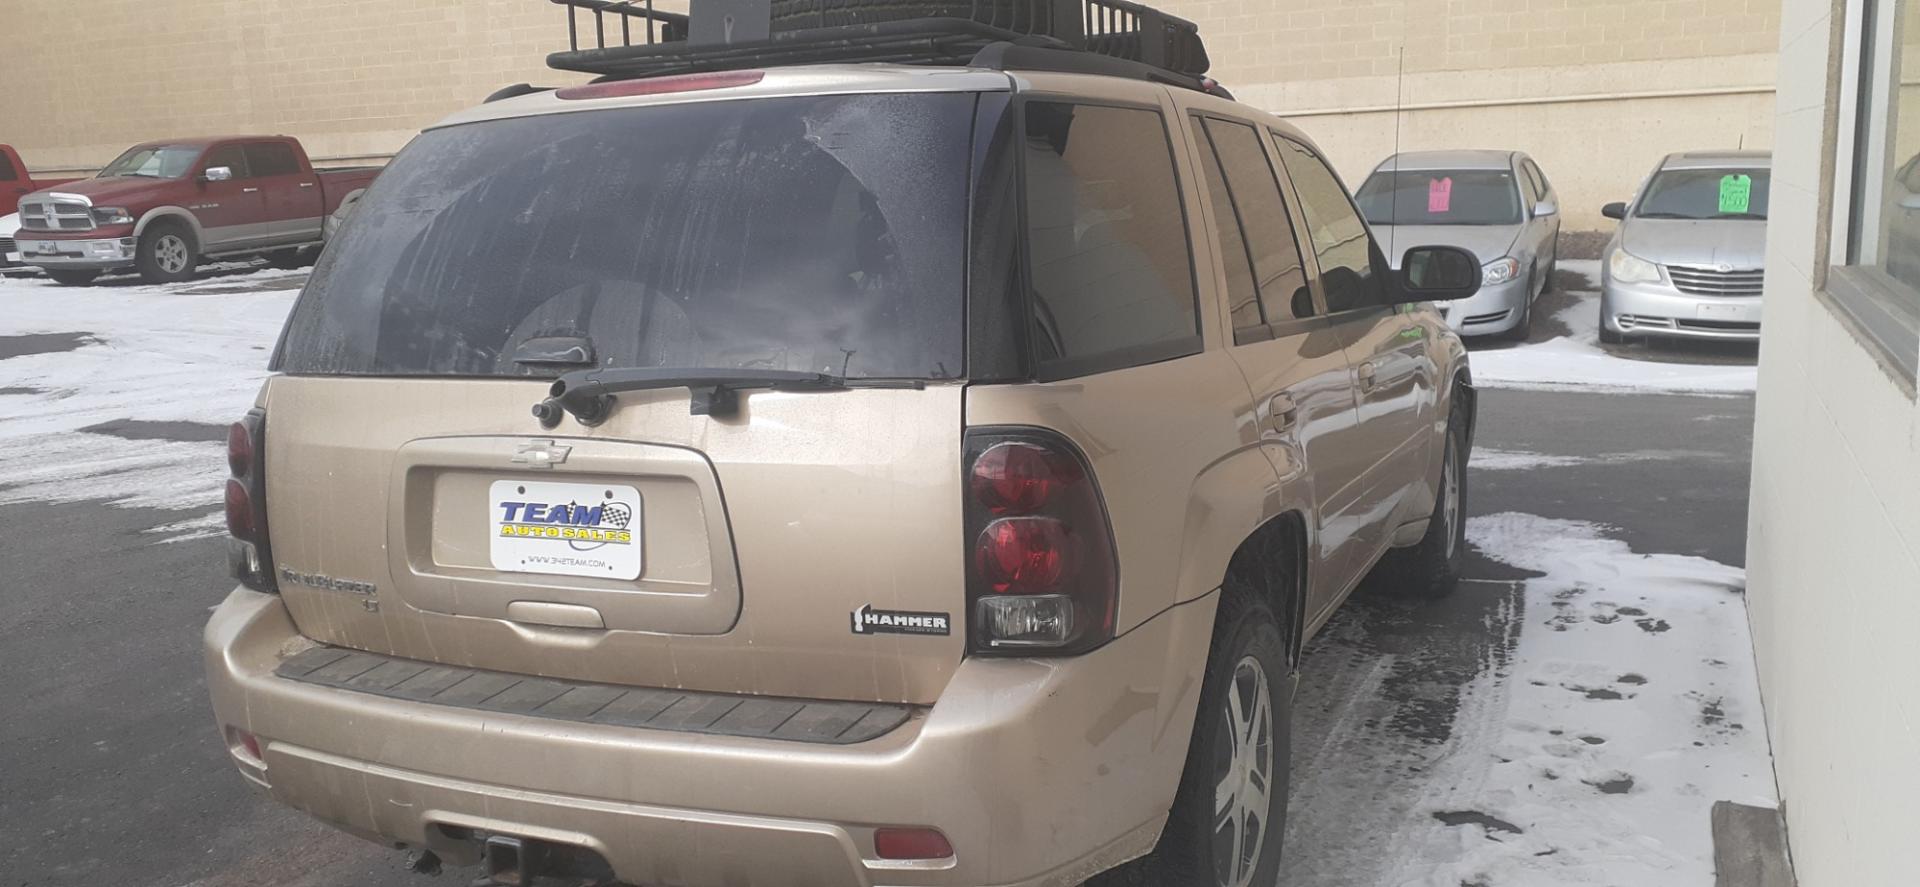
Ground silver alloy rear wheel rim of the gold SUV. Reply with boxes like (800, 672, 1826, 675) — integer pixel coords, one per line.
(1213, 655, 1273, 887)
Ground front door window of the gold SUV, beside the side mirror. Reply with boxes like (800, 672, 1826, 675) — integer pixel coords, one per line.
(1275, 134, 1388, 311)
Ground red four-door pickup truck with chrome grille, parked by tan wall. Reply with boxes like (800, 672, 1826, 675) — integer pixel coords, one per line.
(15, 136, 378, 284)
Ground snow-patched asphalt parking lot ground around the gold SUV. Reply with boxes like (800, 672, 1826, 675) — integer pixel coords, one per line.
(0, 263, 1774, 887)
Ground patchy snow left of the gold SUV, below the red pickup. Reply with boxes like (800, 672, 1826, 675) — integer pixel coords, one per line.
(0, 271, 307, 538)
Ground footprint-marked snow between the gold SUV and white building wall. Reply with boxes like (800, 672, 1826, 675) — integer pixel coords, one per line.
(1288, 513, 1776, 887)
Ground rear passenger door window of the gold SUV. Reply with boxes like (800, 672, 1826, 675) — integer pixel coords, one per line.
(1206, 119, 1313, 323)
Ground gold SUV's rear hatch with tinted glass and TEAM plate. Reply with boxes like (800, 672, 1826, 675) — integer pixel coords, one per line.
(265, 84, 979, 703)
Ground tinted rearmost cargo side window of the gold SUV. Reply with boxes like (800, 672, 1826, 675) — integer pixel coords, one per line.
(1023, 102, 1200, 370)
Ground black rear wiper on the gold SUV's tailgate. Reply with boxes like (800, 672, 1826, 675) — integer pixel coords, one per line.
(534, 367, 925, 428)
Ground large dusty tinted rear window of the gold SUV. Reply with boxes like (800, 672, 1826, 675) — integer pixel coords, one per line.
(276, 94, 975, 378)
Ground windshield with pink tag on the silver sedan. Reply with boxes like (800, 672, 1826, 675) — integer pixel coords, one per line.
(1354, 169, 1521, 225)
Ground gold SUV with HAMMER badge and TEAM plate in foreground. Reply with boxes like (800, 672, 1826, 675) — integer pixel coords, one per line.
(205, 5, 1480, 887)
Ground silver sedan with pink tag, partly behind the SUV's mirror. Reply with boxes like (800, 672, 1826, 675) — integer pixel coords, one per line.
(1356, 152, 1559, 338)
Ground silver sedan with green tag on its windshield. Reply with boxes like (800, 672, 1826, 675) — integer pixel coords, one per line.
(1599, 152, 1772, 342)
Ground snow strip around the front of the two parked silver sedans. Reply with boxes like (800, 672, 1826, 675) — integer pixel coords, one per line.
(1473, 259, 1759, 394)
